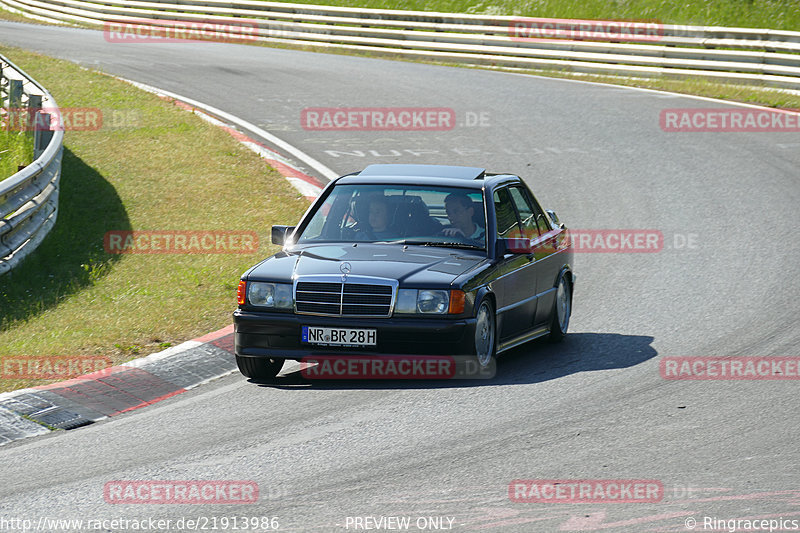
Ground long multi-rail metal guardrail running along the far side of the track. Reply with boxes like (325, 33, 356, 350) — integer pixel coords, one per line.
(0, 0, 800, 89)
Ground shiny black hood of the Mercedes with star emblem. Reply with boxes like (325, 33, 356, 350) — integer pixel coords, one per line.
(247, 244, 486, 287)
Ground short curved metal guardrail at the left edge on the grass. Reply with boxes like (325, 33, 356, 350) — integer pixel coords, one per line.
(0, 55, 64, 275)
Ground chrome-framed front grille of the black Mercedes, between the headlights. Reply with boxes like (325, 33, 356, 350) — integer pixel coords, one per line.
(295, 280, 396, 317)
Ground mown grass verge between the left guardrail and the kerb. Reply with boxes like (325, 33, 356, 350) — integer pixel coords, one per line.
(0, 46, 308, 391)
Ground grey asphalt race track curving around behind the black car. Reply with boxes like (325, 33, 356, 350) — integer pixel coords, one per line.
(0, 22, 800, 531)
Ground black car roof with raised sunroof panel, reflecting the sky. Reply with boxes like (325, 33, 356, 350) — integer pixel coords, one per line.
(337, 164, 519, 189)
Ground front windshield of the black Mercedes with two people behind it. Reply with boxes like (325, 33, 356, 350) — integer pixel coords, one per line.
(297, 185, 486, 250)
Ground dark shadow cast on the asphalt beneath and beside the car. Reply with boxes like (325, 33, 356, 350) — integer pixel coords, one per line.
(250, 333, 658, 390)
